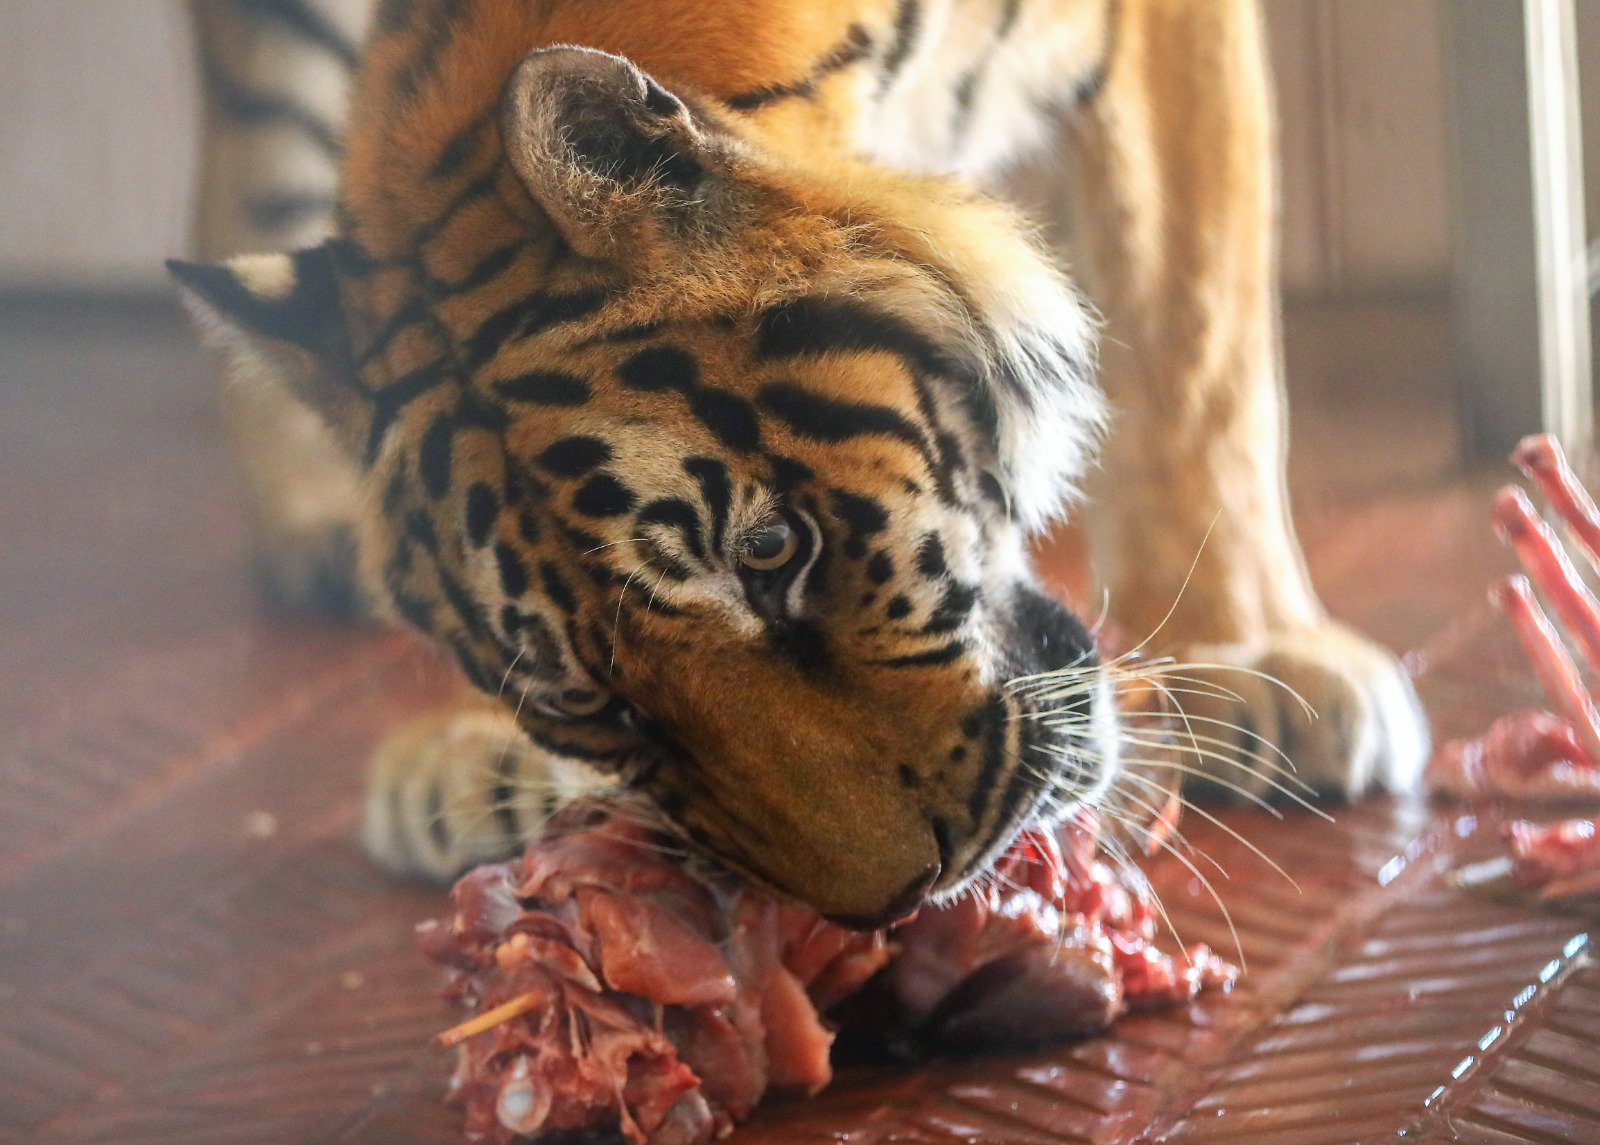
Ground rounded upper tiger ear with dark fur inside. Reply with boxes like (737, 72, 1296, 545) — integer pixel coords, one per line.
(501, 46, 728, 259)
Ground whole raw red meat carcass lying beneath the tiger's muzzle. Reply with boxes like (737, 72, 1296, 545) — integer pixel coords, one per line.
(421, 804, 1237, 1145)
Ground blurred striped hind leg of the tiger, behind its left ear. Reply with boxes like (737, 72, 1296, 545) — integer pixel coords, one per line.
(190, 0, 371, 614)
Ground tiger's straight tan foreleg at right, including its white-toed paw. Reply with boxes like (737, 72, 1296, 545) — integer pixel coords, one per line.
(1072, 0, 1427, 796)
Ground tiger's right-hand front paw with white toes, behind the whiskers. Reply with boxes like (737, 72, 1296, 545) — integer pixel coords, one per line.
(1168, 622, 1429, 800)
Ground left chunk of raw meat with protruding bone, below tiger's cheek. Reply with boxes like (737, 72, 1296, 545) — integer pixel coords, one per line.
(421, 806, 888, 1145)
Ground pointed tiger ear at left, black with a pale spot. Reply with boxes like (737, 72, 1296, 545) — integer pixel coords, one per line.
(166, 243, 371, 454)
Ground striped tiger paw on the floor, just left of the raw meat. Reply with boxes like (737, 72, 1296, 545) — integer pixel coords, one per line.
(362, 704, 611, 881)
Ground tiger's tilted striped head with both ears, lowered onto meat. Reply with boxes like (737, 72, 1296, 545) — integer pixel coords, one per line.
(174, 48, 1114, 924)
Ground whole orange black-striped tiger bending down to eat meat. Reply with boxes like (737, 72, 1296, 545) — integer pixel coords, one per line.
(171, 0, 1427, 926)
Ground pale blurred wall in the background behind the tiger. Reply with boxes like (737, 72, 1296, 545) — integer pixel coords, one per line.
(0, 0, 1600, 299)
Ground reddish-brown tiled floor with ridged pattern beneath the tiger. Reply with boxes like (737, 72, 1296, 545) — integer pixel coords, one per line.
(0, 302, 1600, 1145)
